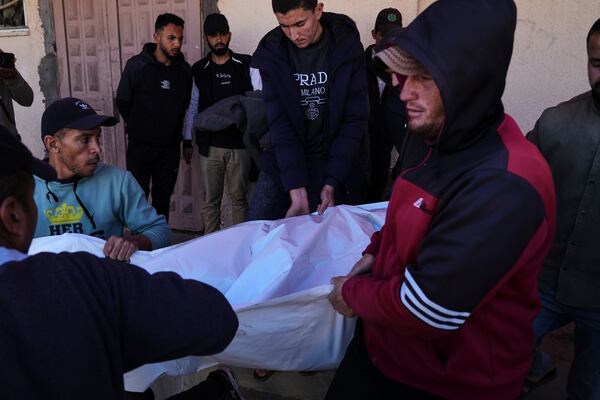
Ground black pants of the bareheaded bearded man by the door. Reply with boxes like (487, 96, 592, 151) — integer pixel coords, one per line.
(127, 141, 181, 222)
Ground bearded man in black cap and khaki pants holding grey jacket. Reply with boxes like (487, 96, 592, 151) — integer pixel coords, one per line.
(183, 14, 253, 234)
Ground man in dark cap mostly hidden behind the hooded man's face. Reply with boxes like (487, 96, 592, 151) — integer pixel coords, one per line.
(365, 8, 406, 202)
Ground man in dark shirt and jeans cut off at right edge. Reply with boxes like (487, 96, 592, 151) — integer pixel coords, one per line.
(527, 19, 600, 400)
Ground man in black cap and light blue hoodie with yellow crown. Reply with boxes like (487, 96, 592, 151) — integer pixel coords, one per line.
(34, 97, 171, 260)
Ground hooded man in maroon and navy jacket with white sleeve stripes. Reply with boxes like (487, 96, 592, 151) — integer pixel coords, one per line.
(327, 0, 555, 400)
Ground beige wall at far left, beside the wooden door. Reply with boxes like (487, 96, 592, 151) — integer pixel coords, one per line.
(0, 0, 45, 156)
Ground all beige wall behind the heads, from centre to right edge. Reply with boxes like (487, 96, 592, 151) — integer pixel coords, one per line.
(218, 0, 600, 132)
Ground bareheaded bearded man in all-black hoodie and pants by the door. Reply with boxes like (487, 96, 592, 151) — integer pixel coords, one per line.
(117, 14, 192, 222)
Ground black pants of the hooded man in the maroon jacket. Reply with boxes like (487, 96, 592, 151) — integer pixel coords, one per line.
(325, 322, 440, 400)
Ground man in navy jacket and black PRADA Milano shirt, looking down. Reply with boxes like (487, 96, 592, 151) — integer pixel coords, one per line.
(248, 0, 368, 219)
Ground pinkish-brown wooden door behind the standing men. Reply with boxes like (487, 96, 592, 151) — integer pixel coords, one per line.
(52, 0, 204, 231)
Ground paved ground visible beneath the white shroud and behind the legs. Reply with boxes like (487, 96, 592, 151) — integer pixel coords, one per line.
(157, 232, 573, 400)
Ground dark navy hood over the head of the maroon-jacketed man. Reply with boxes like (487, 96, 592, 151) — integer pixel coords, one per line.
(388, 0, 517, 151)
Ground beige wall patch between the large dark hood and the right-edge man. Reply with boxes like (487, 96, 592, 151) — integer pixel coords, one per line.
(504, 0, 600, 132)
